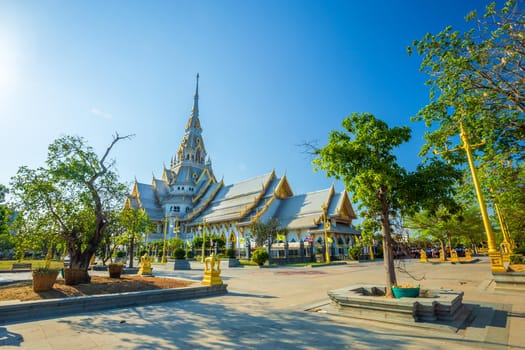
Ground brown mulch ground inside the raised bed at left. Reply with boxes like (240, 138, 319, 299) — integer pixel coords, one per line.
(0, 276, 195, 301)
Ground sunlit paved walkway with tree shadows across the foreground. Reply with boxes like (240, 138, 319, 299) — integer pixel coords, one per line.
(0, 259, 525, 350)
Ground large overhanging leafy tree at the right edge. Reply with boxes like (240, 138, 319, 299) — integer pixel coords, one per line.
(409, 0, 525, 243)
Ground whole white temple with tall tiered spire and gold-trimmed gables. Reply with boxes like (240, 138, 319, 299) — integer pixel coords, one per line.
(126, 75, 359, 255)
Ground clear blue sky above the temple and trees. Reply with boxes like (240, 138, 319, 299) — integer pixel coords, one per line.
(0, 0, 498, 197)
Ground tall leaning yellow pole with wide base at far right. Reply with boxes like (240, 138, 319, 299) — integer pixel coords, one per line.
(460, 123, 506, 272)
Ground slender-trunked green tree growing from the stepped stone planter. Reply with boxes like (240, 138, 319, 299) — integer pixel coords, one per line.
(313, 113, 458, 297)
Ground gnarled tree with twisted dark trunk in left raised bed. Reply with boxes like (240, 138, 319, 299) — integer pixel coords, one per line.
(11, 134, 129, 283)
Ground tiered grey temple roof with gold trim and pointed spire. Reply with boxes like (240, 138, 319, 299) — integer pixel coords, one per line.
(126, 75, 357, 241)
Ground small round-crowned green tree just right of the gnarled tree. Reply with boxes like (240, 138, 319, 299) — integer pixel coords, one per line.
(119, 208, 150, 267)
